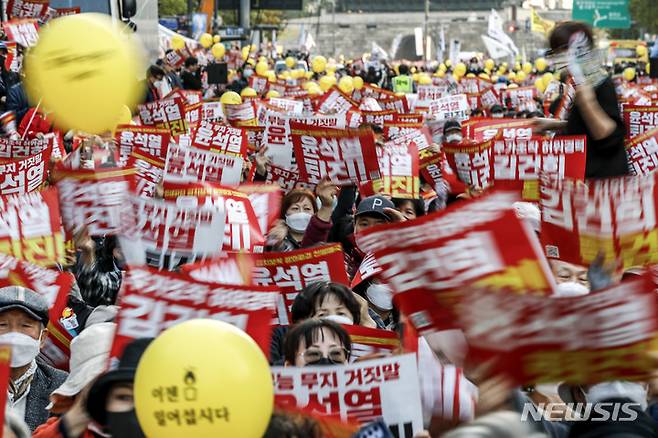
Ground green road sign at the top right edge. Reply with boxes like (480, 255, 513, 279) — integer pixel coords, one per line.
(572, 0, 631, 29)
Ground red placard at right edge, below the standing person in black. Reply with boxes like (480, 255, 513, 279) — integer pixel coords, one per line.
(540, 173, 658, 269)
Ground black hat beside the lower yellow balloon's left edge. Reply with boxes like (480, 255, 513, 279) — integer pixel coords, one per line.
(87, 338, 153, 426)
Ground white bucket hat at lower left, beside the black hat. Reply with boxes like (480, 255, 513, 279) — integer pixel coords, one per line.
(47, 322, 116, 409)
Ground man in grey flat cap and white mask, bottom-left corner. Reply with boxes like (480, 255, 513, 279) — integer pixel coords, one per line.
(0, 286, 67, 430)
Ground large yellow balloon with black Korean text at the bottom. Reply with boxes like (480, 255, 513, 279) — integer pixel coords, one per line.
(134, 319, 274, 438)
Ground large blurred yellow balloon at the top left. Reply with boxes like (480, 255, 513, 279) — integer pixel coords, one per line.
(25, 14, 144, 134)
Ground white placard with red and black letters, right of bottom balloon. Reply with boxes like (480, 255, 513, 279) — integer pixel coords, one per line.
(272, 354, 423, 434)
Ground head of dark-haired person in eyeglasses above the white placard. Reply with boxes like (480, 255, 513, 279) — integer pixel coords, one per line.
(283, 319, 352, 367)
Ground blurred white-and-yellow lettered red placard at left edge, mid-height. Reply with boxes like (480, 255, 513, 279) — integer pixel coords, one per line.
(0, 188, 66, 266)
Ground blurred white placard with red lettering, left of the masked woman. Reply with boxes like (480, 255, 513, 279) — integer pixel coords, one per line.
(121, 196, 225, 270)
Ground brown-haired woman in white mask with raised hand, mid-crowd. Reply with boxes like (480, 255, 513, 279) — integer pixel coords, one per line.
(267, 179, 338, 252)
